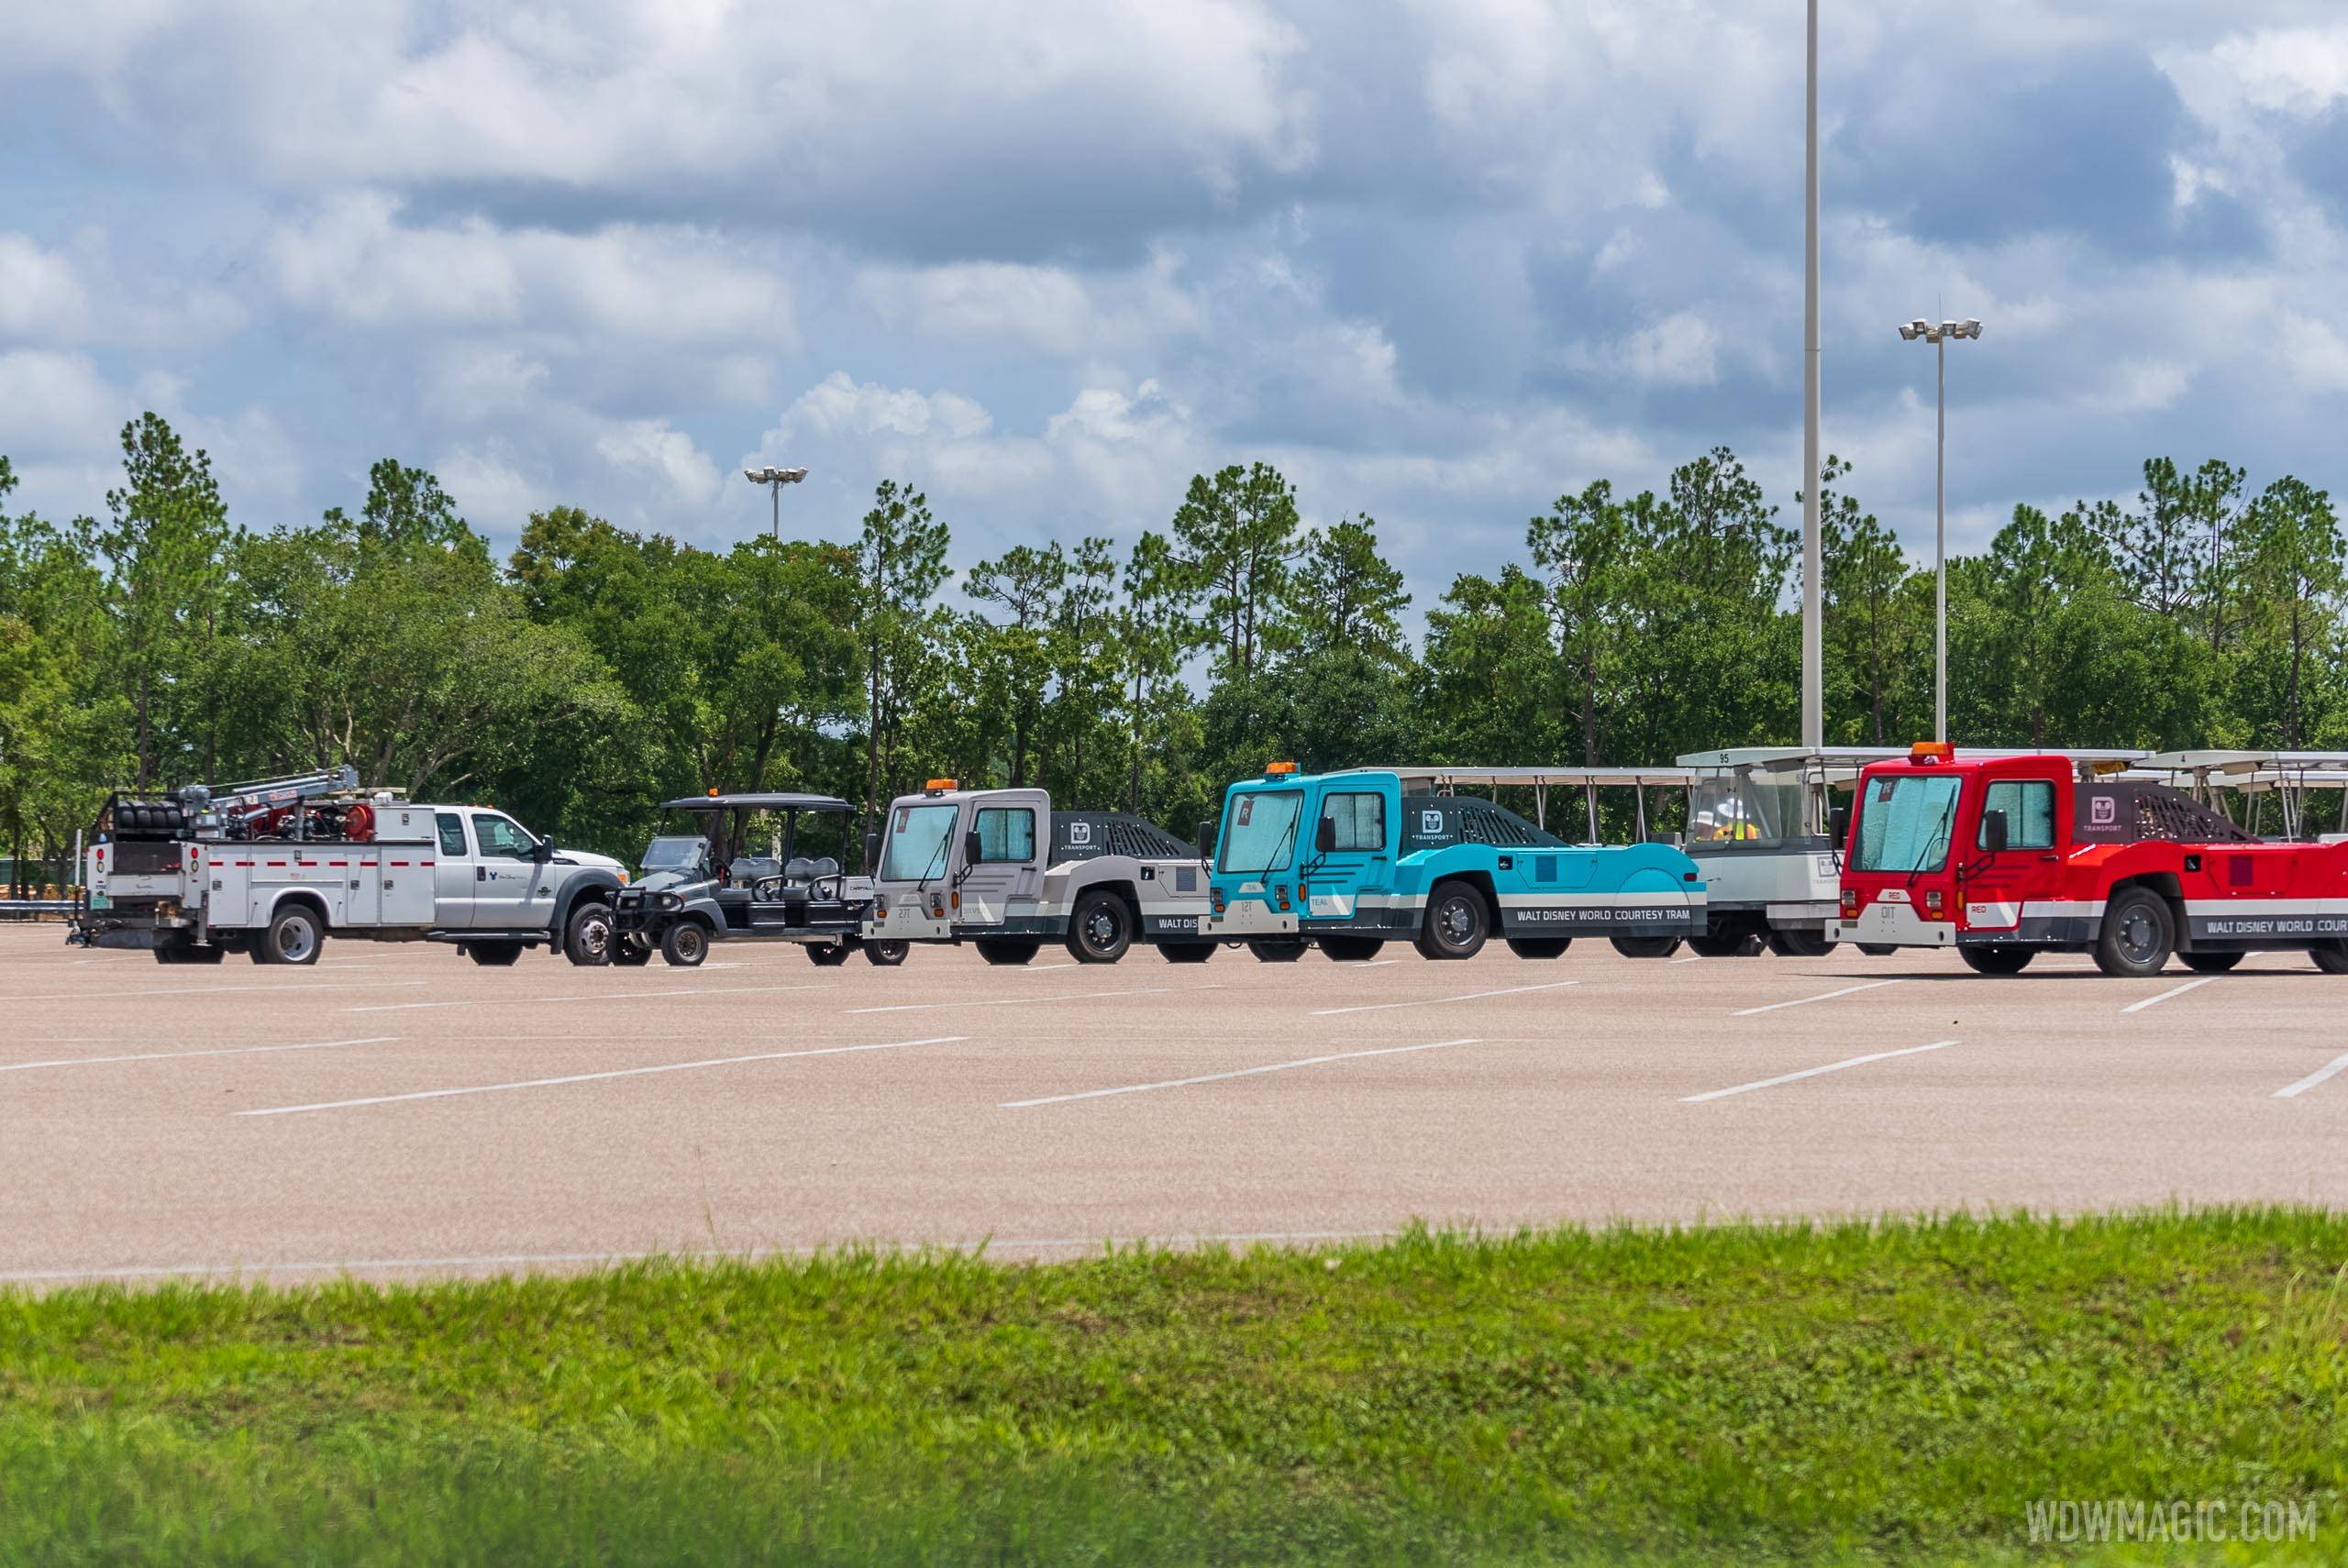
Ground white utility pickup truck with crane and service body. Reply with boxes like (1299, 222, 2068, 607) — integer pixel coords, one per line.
(71, 767, 629, 965)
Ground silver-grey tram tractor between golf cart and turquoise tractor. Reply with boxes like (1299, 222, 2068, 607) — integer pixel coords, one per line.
(867, 779, 1214, 965)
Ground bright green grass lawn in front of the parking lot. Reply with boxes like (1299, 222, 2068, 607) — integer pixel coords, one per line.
(0, 1211, 2348, 1565)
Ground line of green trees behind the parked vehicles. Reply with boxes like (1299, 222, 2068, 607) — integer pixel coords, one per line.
(0, 414, 2348, 882)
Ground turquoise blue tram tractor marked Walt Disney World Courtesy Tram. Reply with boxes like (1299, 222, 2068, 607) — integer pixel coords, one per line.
(1204, 763, 1705, 957)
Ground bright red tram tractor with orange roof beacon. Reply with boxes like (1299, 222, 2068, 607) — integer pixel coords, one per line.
(1838, 744, 2348, 974)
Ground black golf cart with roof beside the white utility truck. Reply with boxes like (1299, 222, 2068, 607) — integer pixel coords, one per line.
(611, 791, 906, 967)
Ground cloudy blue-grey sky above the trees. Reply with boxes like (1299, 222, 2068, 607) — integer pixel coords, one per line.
(0, 0, 2348, 601)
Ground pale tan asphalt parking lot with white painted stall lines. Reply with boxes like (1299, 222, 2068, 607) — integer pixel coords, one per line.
(0, 927, 2348, 1284)
